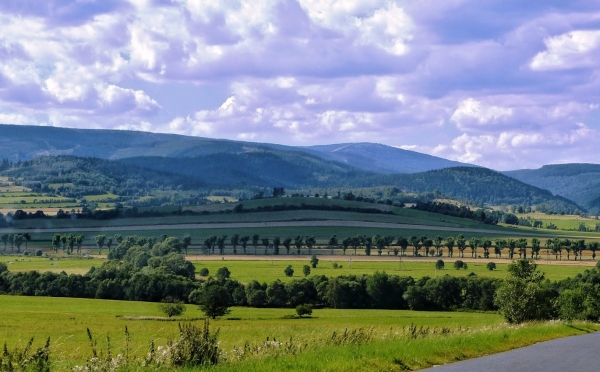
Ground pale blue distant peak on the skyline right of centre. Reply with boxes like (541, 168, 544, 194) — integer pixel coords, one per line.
(306, 143, 470, 174)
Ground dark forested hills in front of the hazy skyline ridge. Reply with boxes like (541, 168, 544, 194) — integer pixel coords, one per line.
(0, 155, 580, 213)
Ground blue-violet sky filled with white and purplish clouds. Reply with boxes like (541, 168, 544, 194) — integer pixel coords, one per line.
(0, 0, 600, 170)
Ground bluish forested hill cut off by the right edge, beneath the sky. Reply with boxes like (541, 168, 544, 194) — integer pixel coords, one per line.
(503, 164, 600, 208)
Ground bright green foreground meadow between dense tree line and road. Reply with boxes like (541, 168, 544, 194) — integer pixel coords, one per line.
(0, 296, 597, 371)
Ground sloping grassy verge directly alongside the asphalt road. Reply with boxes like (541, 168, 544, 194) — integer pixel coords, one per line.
(207, 323, 600, 372)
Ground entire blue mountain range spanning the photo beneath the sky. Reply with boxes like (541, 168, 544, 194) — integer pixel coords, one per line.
(0, 125, 600, 211)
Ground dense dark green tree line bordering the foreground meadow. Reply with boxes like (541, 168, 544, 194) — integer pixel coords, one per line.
(0, 236, 600, 322)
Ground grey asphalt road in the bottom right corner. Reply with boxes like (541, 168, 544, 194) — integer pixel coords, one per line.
(421, 332, 600, 372)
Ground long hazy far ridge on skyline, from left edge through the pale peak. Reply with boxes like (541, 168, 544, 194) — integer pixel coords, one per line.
(0, 125, 465, 174)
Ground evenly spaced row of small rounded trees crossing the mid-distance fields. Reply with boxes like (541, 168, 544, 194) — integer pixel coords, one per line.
(130, 234, 599, 260)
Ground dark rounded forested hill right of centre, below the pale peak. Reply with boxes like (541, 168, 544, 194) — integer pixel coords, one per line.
(390, 167, 581, 213)
